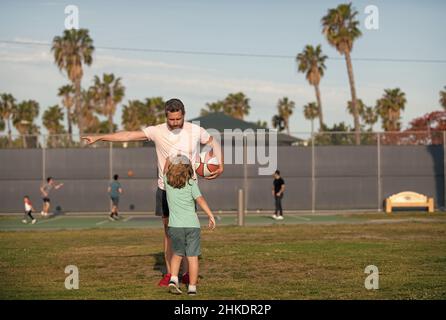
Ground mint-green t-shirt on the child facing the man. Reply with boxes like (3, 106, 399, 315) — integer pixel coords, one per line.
(163, 175, 201, 228)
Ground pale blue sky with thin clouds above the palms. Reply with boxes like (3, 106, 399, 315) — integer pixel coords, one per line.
(0, 0, 446, 133)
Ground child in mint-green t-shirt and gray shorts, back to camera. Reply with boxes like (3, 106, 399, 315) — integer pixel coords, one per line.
(163, 156, 215, 295)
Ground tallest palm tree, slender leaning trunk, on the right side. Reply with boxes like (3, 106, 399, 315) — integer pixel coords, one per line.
(322, 3, 361, 144)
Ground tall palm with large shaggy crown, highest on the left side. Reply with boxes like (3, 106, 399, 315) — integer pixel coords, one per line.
(51, 29, 94, 135)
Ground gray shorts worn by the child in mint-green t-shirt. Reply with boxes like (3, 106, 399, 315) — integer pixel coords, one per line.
(167, 227, 201, 257)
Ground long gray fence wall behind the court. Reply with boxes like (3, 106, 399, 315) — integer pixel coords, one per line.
(0, 146, 444, 212)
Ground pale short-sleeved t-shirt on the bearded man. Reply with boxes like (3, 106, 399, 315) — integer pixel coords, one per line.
(143, 121, 211, 190)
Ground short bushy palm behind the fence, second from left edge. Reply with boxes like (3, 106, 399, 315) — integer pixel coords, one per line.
(12, 100, 39, 148)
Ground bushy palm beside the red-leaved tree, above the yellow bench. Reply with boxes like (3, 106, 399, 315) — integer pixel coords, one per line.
(375, 88, 407, 131)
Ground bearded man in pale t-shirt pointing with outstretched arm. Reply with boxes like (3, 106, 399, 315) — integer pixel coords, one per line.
(82, 99, 224, 286)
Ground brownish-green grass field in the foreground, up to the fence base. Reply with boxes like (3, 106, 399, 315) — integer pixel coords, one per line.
(0, 213, 446, 299)
